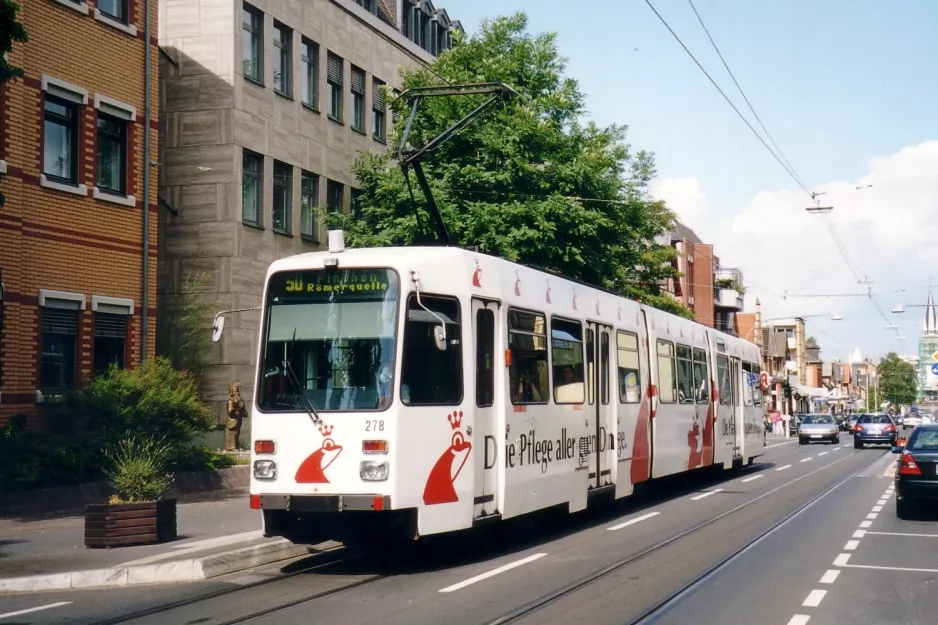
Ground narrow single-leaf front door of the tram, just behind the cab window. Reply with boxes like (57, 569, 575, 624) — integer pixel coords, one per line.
(471, 298, 505, 518)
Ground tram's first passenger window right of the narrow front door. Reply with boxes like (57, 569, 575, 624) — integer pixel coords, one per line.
(508, 310, 550, 404)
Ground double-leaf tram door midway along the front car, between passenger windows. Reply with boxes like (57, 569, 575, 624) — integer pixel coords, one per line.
(586, 321, 617, 488)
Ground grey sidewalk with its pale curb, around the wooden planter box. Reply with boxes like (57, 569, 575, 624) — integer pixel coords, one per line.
(0, 492, 337, 593)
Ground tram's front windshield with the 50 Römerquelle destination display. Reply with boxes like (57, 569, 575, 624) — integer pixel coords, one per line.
(257, 269, 400, 412)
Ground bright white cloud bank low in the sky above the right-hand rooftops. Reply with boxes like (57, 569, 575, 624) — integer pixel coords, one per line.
(654, 141, 938, 358)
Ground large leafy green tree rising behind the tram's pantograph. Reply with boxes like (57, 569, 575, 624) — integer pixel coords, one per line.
(327, 13, 691, 317)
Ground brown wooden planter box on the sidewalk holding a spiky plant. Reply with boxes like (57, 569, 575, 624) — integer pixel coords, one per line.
(85, 499, 176, 548)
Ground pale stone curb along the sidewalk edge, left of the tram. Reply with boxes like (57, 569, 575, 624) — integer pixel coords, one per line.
(0, 539, 341, 593)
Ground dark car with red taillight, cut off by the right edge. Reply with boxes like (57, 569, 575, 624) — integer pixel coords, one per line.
(892, 423, 938, 519)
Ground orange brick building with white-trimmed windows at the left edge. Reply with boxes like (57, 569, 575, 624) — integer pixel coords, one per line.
(0, 0, 158, 425)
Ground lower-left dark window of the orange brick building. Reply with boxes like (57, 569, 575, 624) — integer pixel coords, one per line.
(39, 300, 79, 391)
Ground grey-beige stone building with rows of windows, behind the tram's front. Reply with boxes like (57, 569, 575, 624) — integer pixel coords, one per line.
(159, 0, 460, 422)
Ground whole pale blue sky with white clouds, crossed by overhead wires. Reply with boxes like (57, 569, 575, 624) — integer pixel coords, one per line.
(438, 0, 938, 358)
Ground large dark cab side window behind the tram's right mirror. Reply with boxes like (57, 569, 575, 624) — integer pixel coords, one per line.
(401, 295, 463, 405)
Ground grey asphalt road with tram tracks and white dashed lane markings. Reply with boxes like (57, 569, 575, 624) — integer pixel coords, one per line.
(0, 436, 938, 625)
